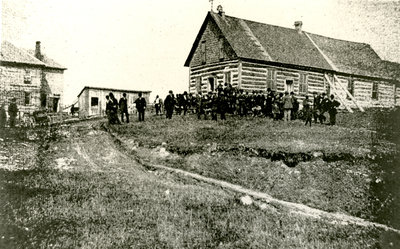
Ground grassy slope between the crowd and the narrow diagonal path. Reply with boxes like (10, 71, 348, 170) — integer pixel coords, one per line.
(112, 110, 400, 228)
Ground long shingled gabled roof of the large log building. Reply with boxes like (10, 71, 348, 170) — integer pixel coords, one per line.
(185, 12, 398, 79)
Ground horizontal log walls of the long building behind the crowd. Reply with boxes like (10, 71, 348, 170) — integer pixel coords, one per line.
(189, 61, 400, 108)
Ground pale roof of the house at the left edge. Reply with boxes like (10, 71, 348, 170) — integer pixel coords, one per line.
(0, 41, 66, 70)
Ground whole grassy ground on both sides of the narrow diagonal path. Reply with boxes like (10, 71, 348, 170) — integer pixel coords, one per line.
(0, 109, 398, 248)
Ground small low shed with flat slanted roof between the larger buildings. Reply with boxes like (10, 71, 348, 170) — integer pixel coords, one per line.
(78, 86, 151, 118)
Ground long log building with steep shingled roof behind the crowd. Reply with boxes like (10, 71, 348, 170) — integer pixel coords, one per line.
(185, 6, 400, 111)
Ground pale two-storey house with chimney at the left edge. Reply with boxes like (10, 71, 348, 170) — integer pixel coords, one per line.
(0, 41, 66, 116)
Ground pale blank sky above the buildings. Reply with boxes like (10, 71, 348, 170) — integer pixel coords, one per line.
(0, 0, 400, 105)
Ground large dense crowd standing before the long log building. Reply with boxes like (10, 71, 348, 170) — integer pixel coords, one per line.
(154, 86, 340, 126)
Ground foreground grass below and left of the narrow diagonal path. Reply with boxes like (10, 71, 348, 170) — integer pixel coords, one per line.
(0, 123, 391, 248)
